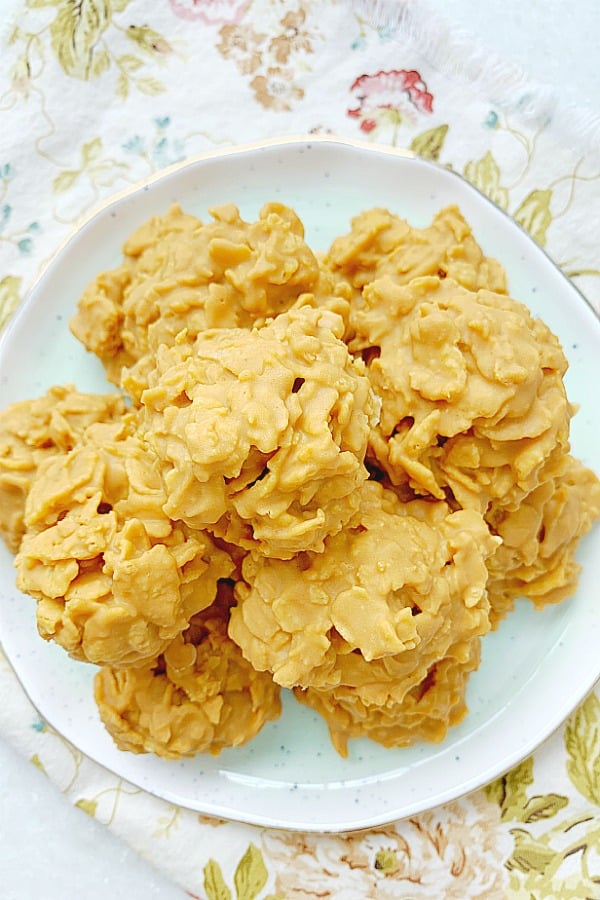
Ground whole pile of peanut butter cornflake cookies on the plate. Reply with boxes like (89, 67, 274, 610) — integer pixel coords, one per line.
(0, 203, 600, 758)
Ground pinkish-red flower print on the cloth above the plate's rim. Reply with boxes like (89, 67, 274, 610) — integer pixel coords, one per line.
(348, 69, 433, 143)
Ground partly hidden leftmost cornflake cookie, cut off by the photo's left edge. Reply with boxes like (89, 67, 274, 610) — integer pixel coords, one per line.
(0, 385, 125, 553)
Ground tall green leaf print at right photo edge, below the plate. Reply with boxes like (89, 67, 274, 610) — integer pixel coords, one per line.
(565, 694, 600, 806)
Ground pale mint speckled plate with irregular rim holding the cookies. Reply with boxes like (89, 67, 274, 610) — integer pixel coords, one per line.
(0, 139, 600, 831)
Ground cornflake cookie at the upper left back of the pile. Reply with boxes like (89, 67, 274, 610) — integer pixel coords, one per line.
(71, 203, 336, 396)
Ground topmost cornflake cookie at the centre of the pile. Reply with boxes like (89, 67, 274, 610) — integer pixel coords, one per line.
(142, 306, 377, 559)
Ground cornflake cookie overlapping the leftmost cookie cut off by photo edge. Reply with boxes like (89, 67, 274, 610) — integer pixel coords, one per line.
(15, 423, 234, 666)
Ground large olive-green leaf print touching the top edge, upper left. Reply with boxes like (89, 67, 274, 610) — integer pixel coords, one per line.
(50, 0, 112, 81)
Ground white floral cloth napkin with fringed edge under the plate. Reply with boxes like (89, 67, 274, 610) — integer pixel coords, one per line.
(0, 0, 600, 900)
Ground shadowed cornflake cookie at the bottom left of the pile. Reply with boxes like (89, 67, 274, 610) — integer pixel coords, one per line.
(94, 585, 281, 759)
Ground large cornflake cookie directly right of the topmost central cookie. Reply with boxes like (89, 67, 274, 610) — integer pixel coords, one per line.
(350, 277, 572, 513)
